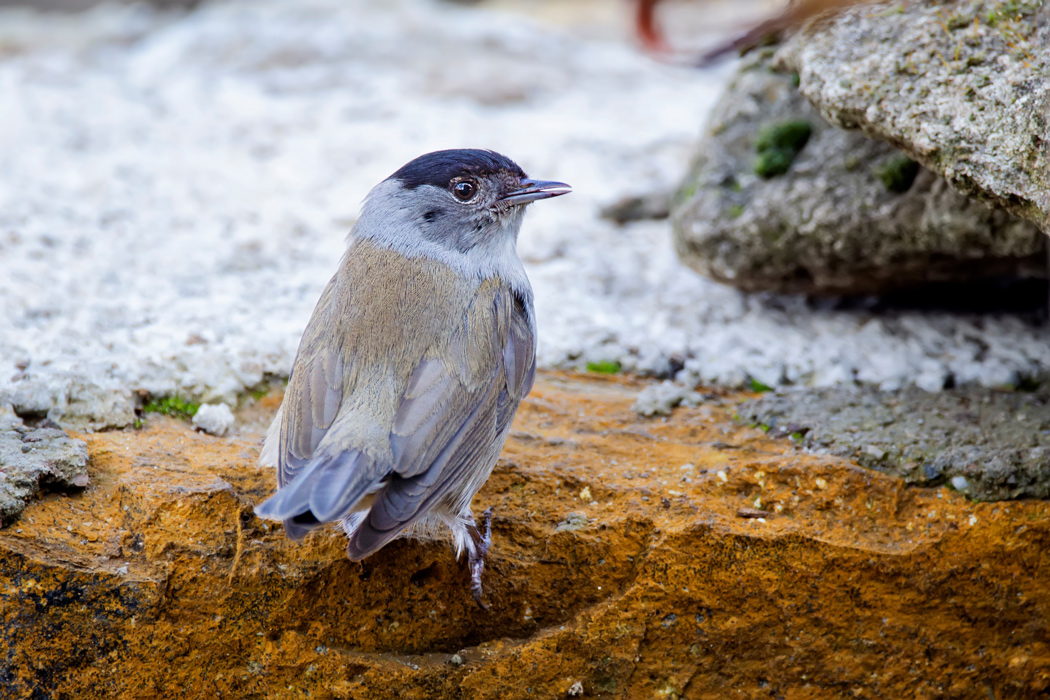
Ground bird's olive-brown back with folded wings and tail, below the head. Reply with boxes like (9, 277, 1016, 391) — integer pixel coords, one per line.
(250, 240, 536, 559)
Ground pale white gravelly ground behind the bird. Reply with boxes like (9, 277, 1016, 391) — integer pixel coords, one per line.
(0, 0, 1050, 428)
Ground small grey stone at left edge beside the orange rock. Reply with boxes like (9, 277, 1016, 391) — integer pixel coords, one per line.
(0, 404, 88, 527)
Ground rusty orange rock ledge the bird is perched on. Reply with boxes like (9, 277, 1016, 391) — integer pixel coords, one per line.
(0, 374, 1050, 700)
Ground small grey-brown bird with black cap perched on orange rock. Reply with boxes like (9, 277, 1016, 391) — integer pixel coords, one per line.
(255, 149, 571, 603)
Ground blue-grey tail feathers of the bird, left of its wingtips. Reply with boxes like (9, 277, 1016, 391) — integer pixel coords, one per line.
(255, 452, 373, 539)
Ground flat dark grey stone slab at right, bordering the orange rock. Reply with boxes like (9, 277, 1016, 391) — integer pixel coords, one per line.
(740, 387, 1050, 500)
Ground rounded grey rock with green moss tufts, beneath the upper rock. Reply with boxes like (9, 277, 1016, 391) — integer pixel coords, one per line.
(673, 50, 1046, 295)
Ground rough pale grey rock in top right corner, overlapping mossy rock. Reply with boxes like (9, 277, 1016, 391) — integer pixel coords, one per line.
(778, 0, 1050, 233)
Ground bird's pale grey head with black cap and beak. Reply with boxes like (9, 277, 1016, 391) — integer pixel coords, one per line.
(358, 149, 572, 266)
